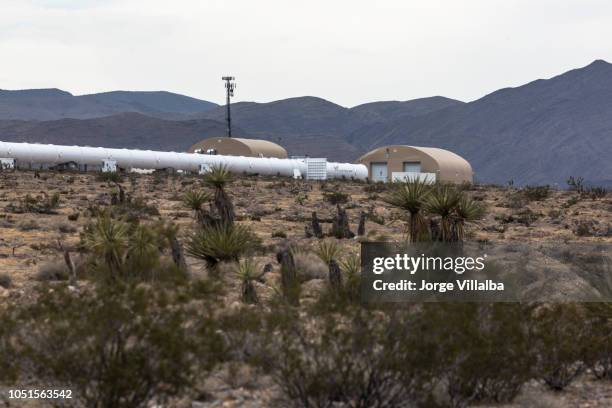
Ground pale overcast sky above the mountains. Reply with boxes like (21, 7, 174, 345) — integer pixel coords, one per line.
(0, 0, 612, 106)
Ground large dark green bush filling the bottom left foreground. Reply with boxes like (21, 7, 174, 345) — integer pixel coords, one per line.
(16, 285, 221, 408)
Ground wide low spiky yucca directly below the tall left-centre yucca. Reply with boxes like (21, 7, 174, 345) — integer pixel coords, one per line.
(187, 223, 258, 270)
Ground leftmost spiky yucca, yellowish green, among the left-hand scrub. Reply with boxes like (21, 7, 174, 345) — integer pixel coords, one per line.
(85, 212, 130, 277)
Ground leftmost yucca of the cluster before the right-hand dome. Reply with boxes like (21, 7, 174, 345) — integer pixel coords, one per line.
(383, 179, 431, 242)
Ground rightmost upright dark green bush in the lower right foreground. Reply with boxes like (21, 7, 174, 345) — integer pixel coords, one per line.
(531, 303, 588, 391)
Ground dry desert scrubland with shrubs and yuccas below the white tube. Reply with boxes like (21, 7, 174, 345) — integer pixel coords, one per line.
(0, 168, 612, 408)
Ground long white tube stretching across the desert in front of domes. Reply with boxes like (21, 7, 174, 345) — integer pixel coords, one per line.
(0, 142, 368, 180)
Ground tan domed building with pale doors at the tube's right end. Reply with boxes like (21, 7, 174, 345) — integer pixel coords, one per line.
(357, 145, 474, 184)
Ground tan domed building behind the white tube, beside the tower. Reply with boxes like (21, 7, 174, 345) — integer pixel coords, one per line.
(188, 137, 287, 159)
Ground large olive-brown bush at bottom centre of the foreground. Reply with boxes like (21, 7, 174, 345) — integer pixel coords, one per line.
(263, 309, 432, 407)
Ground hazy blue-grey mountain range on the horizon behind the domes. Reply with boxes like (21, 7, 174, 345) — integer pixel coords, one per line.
(0, 60, 612, 186)
